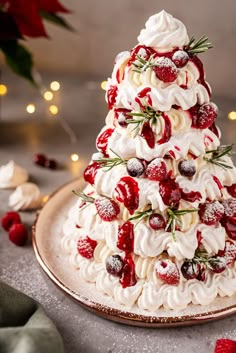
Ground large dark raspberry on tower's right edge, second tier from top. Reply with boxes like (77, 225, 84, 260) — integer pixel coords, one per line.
(196, 103, 217, 129)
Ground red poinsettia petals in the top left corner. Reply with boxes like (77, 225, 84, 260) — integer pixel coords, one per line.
(0, 0, 69, 37)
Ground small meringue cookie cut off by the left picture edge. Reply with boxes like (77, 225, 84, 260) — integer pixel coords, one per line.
(0, 161, 29, 189)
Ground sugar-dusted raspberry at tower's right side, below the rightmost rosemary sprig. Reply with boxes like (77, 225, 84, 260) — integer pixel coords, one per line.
(198, 201, 224, 225)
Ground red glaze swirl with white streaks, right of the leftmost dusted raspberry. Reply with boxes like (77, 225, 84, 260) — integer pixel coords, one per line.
(115, 176, 139, 215)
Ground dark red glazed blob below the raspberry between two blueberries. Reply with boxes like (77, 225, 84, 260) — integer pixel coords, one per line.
(159, 179, 181, 206)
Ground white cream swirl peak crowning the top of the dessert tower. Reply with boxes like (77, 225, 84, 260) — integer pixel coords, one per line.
(138, 10, 189, 51)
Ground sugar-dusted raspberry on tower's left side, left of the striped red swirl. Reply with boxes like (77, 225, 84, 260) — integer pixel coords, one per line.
(95, 197, 120, 222)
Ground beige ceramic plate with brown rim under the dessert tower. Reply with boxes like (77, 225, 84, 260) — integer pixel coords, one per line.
(33, 179, 236, 327)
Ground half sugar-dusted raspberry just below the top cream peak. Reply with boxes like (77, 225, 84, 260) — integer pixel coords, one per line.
(153, 56, 178, 83)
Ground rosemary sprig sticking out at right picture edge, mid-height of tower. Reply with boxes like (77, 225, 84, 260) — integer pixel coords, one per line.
(203, 144, 235, 169)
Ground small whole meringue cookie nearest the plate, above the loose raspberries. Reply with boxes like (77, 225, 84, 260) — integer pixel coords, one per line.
(8, 183, 42, 211)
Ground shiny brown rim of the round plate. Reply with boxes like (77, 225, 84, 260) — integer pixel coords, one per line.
(32, 176, 236, 328)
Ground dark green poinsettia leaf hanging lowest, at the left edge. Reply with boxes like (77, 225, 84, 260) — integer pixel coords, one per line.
(0, 40, 37, 86)
